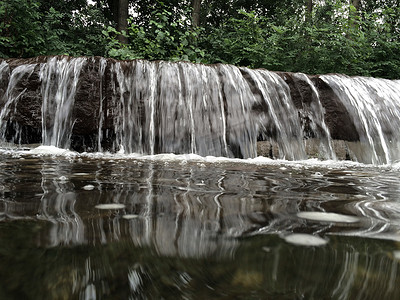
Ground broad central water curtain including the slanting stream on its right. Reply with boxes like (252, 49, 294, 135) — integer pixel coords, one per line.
(111, 61, 306, 159)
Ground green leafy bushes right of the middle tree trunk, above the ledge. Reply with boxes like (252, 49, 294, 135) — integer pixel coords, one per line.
(200, 1, 400, 78)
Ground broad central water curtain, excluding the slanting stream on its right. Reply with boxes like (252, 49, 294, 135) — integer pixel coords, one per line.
(112, 61, 257, 157)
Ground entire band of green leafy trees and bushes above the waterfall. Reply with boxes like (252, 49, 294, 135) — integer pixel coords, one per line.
(0, 0, 400, 78)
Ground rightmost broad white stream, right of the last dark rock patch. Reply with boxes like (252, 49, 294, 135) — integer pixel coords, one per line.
(321, 75, 400, 164)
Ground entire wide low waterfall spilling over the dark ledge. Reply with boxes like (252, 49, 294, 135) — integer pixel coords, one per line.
(0, 56, 400, 164)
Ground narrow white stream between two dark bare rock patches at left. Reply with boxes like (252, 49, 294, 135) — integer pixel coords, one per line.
(40, 57, 86, 148)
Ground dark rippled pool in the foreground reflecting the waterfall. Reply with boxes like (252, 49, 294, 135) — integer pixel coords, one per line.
(0, 152, 400, 299)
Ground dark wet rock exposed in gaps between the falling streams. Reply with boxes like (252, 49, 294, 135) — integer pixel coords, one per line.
(0, 57, 359, 152)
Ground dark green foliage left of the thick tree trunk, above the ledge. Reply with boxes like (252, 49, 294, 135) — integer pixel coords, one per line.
(0, 0, 109, 57)
